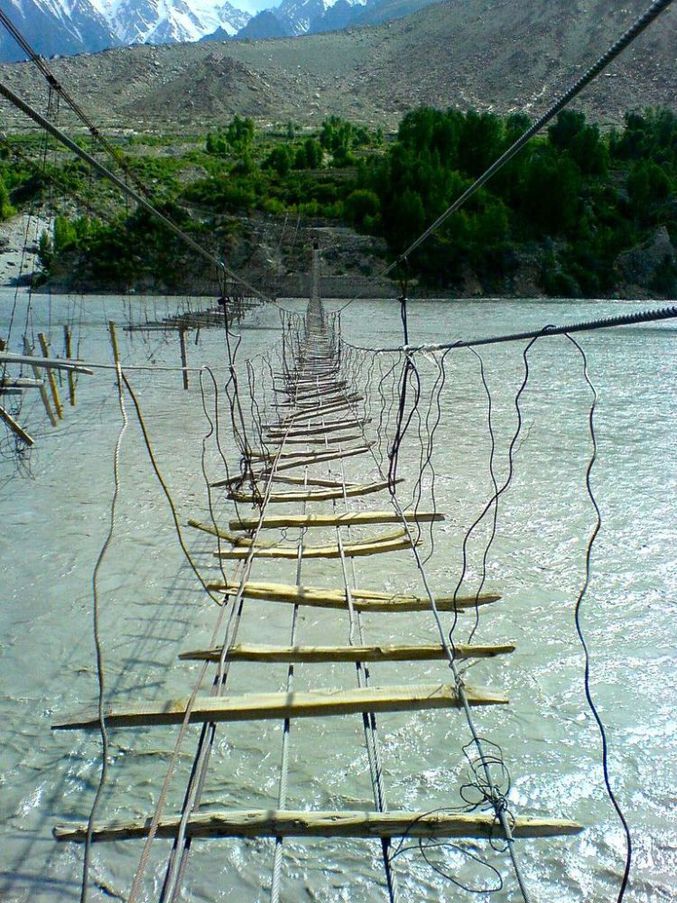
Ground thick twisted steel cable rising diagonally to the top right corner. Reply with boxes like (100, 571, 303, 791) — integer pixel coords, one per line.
(380, 0, 672, 277)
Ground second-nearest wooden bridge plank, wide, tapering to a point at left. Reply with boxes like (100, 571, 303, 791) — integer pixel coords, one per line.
(52, 683, 508, 730)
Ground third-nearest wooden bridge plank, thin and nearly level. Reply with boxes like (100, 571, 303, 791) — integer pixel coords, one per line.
(179, 643, 515, 664)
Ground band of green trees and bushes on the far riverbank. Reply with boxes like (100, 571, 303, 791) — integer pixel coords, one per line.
(0, 108, 677, 296)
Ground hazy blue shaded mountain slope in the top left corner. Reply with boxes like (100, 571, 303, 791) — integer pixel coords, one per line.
(0, 0, 120, 61)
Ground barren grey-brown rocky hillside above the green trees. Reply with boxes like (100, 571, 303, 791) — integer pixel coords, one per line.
(0, 0, 677, 130)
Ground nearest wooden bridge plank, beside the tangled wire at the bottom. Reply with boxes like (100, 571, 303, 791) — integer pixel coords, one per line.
(53, 809, 583, 843)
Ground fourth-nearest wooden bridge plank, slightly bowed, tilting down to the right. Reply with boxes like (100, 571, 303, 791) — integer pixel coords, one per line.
(207, 581, 501, 612)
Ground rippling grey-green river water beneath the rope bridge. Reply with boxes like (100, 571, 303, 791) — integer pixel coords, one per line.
(0, 291, 677, 903)
